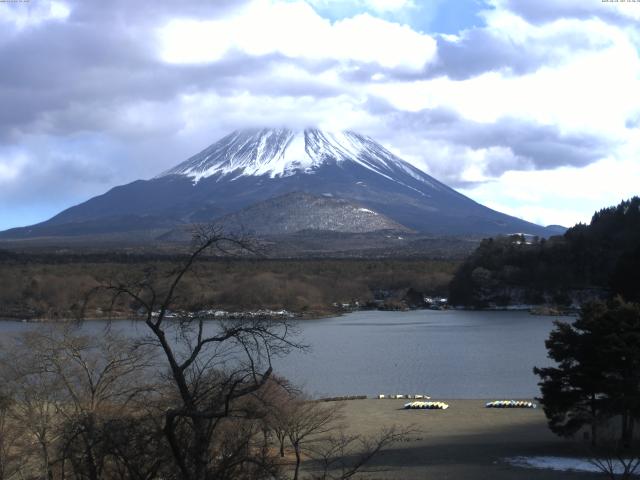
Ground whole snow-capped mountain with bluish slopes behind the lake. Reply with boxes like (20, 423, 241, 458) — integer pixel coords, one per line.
(0, 129, 560, 244)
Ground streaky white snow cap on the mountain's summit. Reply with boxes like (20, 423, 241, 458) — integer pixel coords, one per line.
(156, 128, 439, 193)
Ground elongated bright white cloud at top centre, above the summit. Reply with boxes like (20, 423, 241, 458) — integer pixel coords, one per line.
(158, 0, 436, 69)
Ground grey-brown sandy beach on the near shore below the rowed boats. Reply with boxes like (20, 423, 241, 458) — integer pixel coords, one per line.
(332, 399, 599, 480)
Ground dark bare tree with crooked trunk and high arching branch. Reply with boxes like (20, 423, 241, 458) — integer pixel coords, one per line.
(106, 227, 299, 480)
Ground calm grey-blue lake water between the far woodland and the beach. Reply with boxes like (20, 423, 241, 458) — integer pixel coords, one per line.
(0, 310, 569, 398)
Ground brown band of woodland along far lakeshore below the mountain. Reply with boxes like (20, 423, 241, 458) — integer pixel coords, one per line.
(0, 253, 459, 319)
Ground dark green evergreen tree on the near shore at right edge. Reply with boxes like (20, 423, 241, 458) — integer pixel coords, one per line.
(534, 298, 640, 446)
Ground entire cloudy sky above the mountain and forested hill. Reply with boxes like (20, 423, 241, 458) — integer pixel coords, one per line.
(0, 0, 640, 229)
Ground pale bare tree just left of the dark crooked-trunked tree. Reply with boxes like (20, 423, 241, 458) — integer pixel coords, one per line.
(42, 331, 153, 480)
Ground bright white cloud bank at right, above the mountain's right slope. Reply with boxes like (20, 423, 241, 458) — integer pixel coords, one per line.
(369, 14, 640, 136)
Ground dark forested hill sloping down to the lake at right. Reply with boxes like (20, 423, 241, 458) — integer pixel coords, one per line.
(450, 197, 640, 307)
